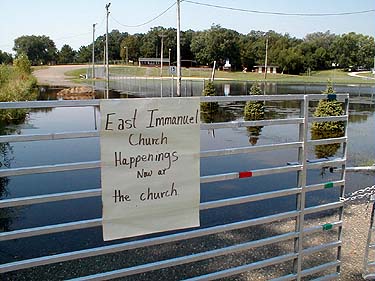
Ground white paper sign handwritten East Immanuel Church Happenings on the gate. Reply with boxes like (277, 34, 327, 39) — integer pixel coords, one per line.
(100, 98, 200, 241)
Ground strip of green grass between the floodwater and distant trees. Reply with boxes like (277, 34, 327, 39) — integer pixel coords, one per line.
(65, 66, 375, 84)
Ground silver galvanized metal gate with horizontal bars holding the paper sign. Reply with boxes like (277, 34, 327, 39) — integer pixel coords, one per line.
(0, 94, 349, 281)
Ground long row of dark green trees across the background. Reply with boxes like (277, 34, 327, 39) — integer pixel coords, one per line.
(0, 25, 375, 74)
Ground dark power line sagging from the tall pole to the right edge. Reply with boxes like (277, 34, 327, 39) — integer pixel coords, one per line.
(183, 0, 375, 17)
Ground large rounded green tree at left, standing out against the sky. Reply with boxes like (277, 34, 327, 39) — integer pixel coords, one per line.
(13, 35, 57, 65)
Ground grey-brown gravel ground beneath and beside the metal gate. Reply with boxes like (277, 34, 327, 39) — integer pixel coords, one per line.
(0, 200, 371, 281)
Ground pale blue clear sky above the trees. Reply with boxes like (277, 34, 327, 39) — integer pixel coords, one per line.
(0, 0, 375, 53)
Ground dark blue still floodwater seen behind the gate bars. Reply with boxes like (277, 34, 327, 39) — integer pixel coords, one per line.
(0, 81, 375, 263)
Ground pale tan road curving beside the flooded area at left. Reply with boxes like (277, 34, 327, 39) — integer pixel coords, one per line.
(33, 65, 86, 87)
